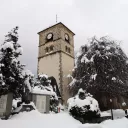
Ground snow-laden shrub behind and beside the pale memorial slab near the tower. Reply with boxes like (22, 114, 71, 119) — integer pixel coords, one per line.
(33, 74, 59, 111)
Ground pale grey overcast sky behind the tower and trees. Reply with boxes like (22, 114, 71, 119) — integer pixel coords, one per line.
(0, 0, 128, 74)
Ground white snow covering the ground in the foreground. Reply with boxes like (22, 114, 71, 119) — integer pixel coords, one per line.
(0, 110, 128, 128)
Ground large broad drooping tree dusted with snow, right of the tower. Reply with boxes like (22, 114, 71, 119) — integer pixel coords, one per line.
(70, 37, 128, 105)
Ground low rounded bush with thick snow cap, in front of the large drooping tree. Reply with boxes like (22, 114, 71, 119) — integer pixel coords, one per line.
(67, 89, 100, 121)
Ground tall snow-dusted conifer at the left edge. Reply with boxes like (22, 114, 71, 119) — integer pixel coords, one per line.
(0, 27, 25, 98)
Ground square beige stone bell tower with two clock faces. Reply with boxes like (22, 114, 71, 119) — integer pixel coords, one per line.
(38, 22, 75, 103)
